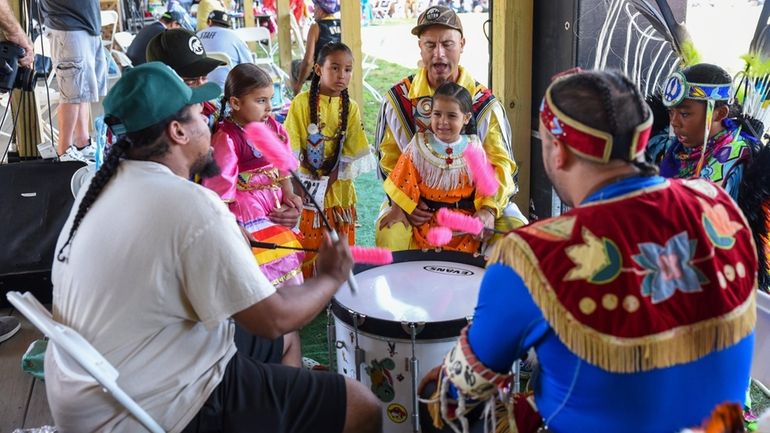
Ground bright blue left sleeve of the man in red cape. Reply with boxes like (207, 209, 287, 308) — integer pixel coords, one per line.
(468, 264, 550, 373)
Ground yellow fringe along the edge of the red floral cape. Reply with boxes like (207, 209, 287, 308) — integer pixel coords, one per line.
(489, 233, 756, 373)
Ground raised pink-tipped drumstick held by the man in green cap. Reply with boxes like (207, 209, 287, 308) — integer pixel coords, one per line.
(243, 122, 358, 295)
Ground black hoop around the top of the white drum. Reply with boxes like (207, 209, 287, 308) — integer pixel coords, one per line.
(331, 250, 486, 341)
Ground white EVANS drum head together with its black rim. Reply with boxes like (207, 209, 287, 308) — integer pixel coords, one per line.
(332, 251, 484, 338)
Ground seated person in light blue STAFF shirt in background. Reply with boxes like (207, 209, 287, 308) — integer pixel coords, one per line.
(198, 11, 254, 88)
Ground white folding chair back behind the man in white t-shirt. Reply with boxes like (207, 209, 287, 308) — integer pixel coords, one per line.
(6, 292, 164, 433)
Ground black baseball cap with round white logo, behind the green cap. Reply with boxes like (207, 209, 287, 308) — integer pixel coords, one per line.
(146, 29, 225, 78)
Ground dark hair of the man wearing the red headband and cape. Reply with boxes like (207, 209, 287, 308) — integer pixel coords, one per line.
(551, 71, 658, 176)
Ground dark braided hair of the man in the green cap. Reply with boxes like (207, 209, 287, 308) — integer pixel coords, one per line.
(56, 107, 192, 262)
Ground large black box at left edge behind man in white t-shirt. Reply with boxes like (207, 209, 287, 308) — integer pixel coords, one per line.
(0, 160, 85, 303)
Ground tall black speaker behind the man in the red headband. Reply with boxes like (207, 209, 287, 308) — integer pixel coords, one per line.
(530, 0, 687, 219)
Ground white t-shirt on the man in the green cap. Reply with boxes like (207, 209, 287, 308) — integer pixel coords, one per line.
(45, 161, 275, 433)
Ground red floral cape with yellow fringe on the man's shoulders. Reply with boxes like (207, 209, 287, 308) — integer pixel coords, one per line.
(489, 179, 757, 373)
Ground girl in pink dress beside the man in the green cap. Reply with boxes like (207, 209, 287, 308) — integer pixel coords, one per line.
(203, 63, 303, 287)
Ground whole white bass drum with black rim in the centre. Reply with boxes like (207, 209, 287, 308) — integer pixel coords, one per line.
(331, 251, 485, 433)
